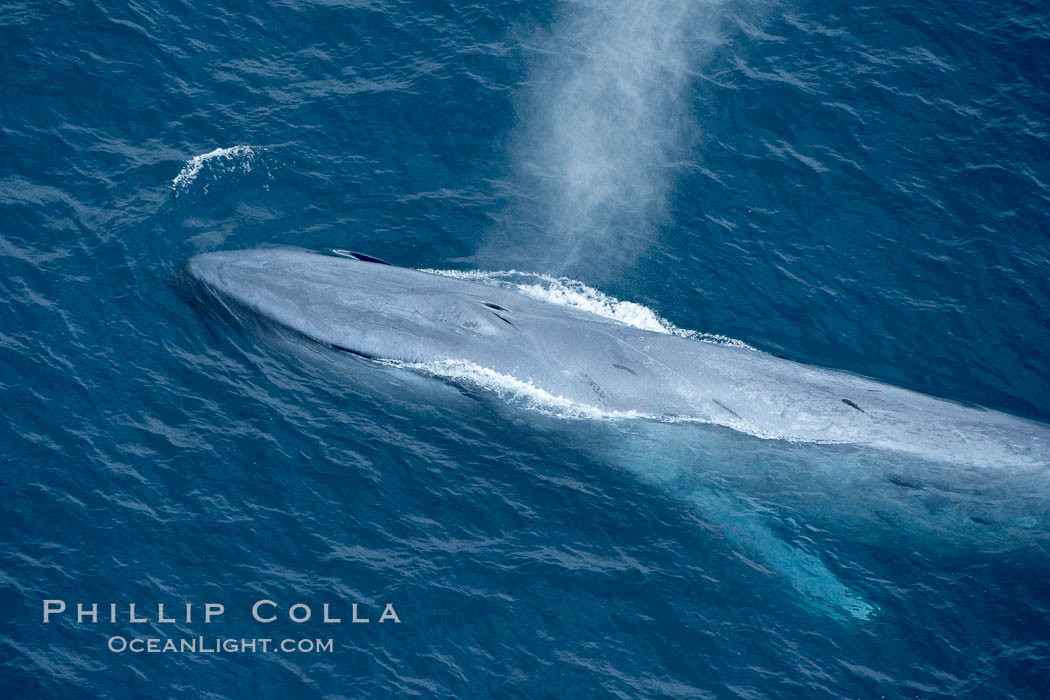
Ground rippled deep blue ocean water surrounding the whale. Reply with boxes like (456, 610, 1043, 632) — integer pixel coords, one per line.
(0, 0, 1050, 698)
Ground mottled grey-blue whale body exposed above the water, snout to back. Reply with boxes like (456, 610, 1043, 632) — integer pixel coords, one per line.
(188, 249, 1050, 466)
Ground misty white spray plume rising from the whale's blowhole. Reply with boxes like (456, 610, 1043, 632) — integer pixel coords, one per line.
(489, 0, 718, 271)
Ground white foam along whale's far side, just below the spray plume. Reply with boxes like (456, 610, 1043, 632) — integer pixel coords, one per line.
(421, 265, 755, 351)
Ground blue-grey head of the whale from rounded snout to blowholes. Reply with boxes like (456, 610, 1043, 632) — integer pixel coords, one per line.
(187, 248, 516, 362)
